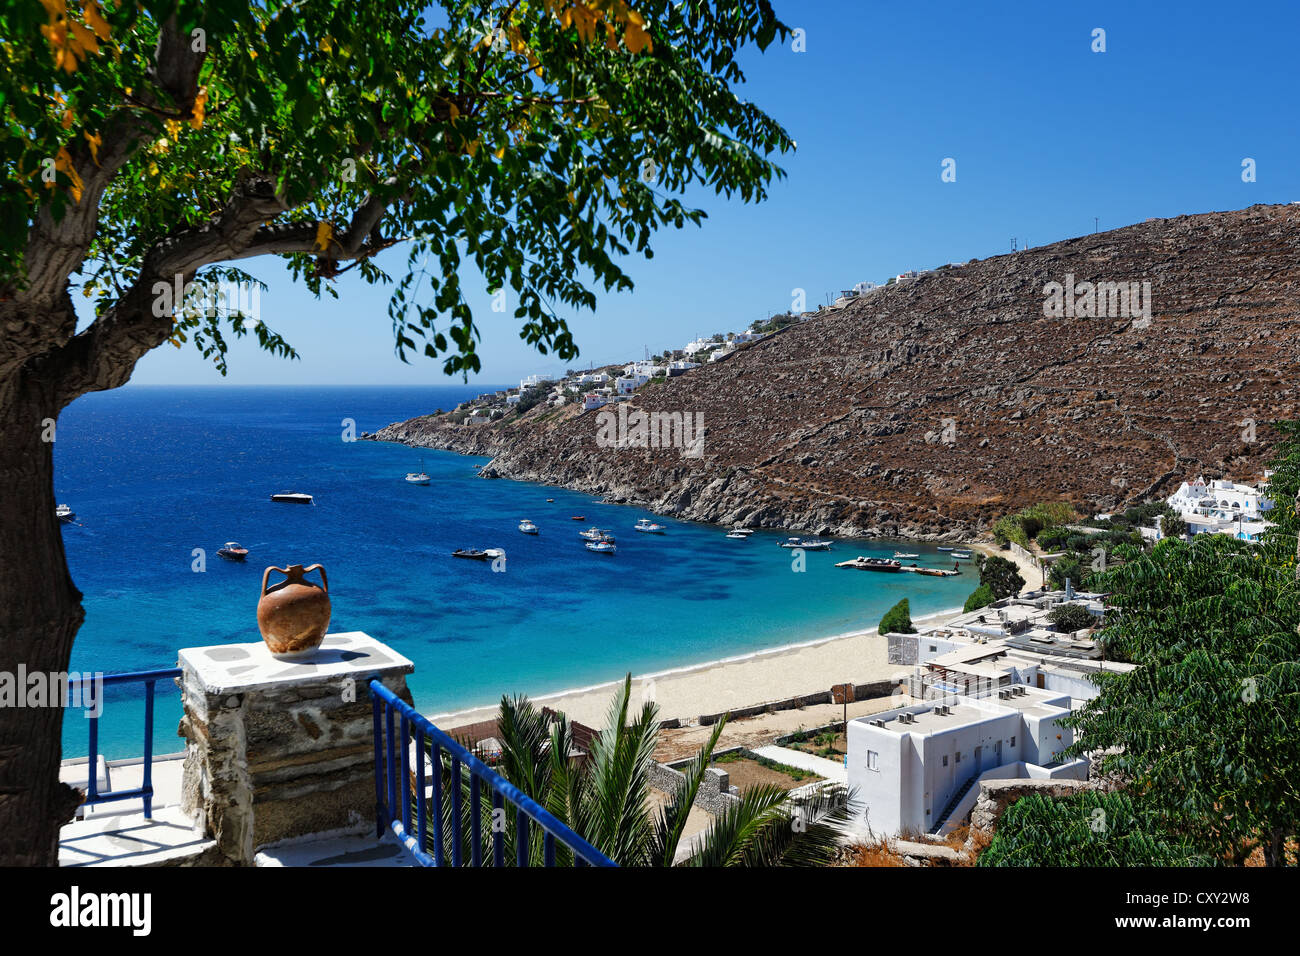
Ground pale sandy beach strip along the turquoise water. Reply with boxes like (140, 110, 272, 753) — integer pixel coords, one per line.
(421, 606, 962, 728)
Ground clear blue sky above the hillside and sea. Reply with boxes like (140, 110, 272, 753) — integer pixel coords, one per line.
(124, 0, 1300, 385)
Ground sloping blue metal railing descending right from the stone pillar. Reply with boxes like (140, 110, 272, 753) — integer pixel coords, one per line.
(369, 679, 618, 866)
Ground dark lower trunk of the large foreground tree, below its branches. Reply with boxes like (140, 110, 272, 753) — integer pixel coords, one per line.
(0, 363, 85, 866)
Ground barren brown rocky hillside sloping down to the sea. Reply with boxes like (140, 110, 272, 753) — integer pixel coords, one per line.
(368, 206, 1300, 537)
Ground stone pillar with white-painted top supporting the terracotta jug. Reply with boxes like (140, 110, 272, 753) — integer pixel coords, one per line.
(178, 631, 415, 865)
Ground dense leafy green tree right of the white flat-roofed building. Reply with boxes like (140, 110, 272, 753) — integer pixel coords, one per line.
(989, 423, 1300, 865)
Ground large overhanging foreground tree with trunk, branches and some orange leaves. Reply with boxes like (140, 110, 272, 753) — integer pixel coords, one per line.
(0, 0, 792, 865)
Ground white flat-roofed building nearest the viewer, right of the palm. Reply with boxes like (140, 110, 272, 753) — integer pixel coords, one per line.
(848, 684, 1088, 836)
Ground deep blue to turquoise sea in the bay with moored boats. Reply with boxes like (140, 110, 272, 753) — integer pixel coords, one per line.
(55, 385, 975, 757)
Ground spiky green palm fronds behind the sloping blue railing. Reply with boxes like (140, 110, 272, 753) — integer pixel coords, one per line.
(429, 674, 857, 866)
